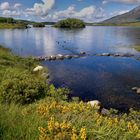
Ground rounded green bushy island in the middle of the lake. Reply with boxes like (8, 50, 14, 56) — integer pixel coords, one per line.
(54, 18, 85, 29)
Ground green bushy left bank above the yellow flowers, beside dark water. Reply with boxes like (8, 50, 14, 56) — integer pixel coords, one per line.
(0, 47, 69, 104)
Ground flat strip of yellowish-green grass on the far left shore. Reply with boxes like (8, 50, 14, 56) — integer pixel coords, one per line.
(0, 23, 27, 29)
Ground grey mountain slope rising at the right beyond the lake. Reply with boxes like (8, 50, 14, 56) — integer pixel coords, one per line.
(102, 6, 140, 24)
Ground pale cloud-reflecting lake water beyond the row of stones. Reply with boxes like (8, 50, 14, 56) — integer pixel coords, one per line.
(0, 27, 140, 56)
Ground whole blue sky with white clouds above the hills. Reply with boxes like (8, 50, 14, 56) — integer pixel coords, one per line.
(0, 0, 140, 22)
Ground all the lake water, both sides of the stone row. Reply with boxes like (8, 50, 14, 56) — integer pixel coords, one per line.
(0, 26, 140, 110)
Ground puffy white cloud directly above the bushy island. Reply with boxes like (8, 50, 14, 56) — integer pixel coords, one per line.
(46, 5, 105, 22)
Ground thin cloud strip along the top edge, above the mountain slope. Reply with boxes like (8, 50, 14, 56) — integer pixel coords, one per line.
(102, 0, 140, 4)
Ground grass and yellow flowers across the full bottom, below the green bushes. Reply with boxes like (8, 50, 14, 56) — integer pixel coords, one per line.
(0, 97, 140, 140)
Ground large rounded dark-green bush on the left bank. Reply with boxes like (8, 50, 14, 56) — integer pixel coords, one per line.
(0, 68, 48, 104)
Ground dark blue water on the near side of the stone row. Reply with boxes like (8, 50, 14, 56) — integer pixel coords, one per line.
(43, 57, 140, 110)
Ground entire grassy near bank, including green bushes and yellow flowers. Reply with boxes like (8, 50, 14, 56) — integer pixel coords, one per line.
(0, 47, 140, 140)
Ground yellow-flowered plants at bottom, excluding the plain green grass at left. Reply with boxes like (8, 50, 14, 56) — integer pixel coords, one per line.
(37, 100, 140, 140)
